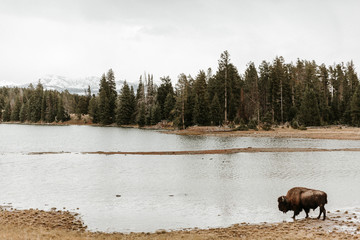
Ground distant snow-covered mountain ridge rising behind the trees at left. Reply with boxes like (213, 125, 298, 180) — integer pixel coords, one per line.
(0, 75, 137, 95)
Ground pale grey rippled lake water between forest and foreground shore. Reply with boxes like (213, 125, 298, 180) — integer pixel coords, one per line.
(0, 124, 360, 232)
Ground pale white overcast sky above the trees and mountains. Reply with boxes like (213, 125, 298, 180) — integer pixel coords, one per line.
(0, 0, 360, 83)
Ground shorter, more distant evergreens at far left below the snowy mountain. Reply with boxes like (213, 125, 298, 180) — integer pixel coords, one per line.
(0, 82, 91, 123)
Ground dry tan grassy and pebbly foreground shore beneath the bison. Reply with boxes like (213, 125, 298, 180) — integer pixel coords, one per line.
(0, 208, 360, 240)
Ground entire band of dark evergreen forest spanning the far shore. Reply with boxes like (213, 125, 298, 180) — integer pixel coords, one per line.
(0, 51, 360, 129)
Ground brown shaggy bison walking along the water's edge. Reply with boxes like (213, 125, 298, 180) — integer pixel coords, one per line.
(278, 187, 327, 220)
